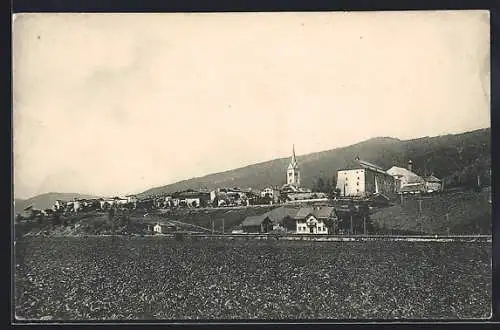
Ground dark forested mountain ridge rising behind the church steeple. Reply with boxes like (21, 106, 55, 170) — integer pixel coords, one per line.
(138, 127, 491, 197)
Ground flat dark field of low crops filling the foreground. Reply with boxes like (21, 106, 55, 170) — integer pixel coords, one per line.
(15, 237, 491, 320)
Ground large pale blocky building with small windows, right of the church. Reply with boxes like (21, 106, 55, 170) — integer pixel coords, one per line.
(336, 157, 396, 197)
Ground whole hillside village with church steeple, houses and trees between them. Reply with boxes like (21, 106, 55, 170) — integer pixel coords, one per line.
(17, 142, 491, 235)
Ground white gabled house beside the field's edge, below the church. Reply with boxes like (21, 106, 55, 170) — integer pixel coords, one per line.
(294, 206, 336, 234)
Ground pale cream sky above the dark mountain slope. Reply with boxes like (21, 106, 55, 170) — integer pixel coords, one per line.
(13, 11, 490, 198)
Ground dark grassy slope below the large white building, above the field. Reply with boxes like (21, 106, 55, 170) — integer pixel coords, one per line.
(371, 191, 492, 234)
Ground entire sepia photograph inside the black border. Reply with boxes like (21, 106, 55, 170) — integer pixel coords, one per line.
(11, 10, 493, 323)
